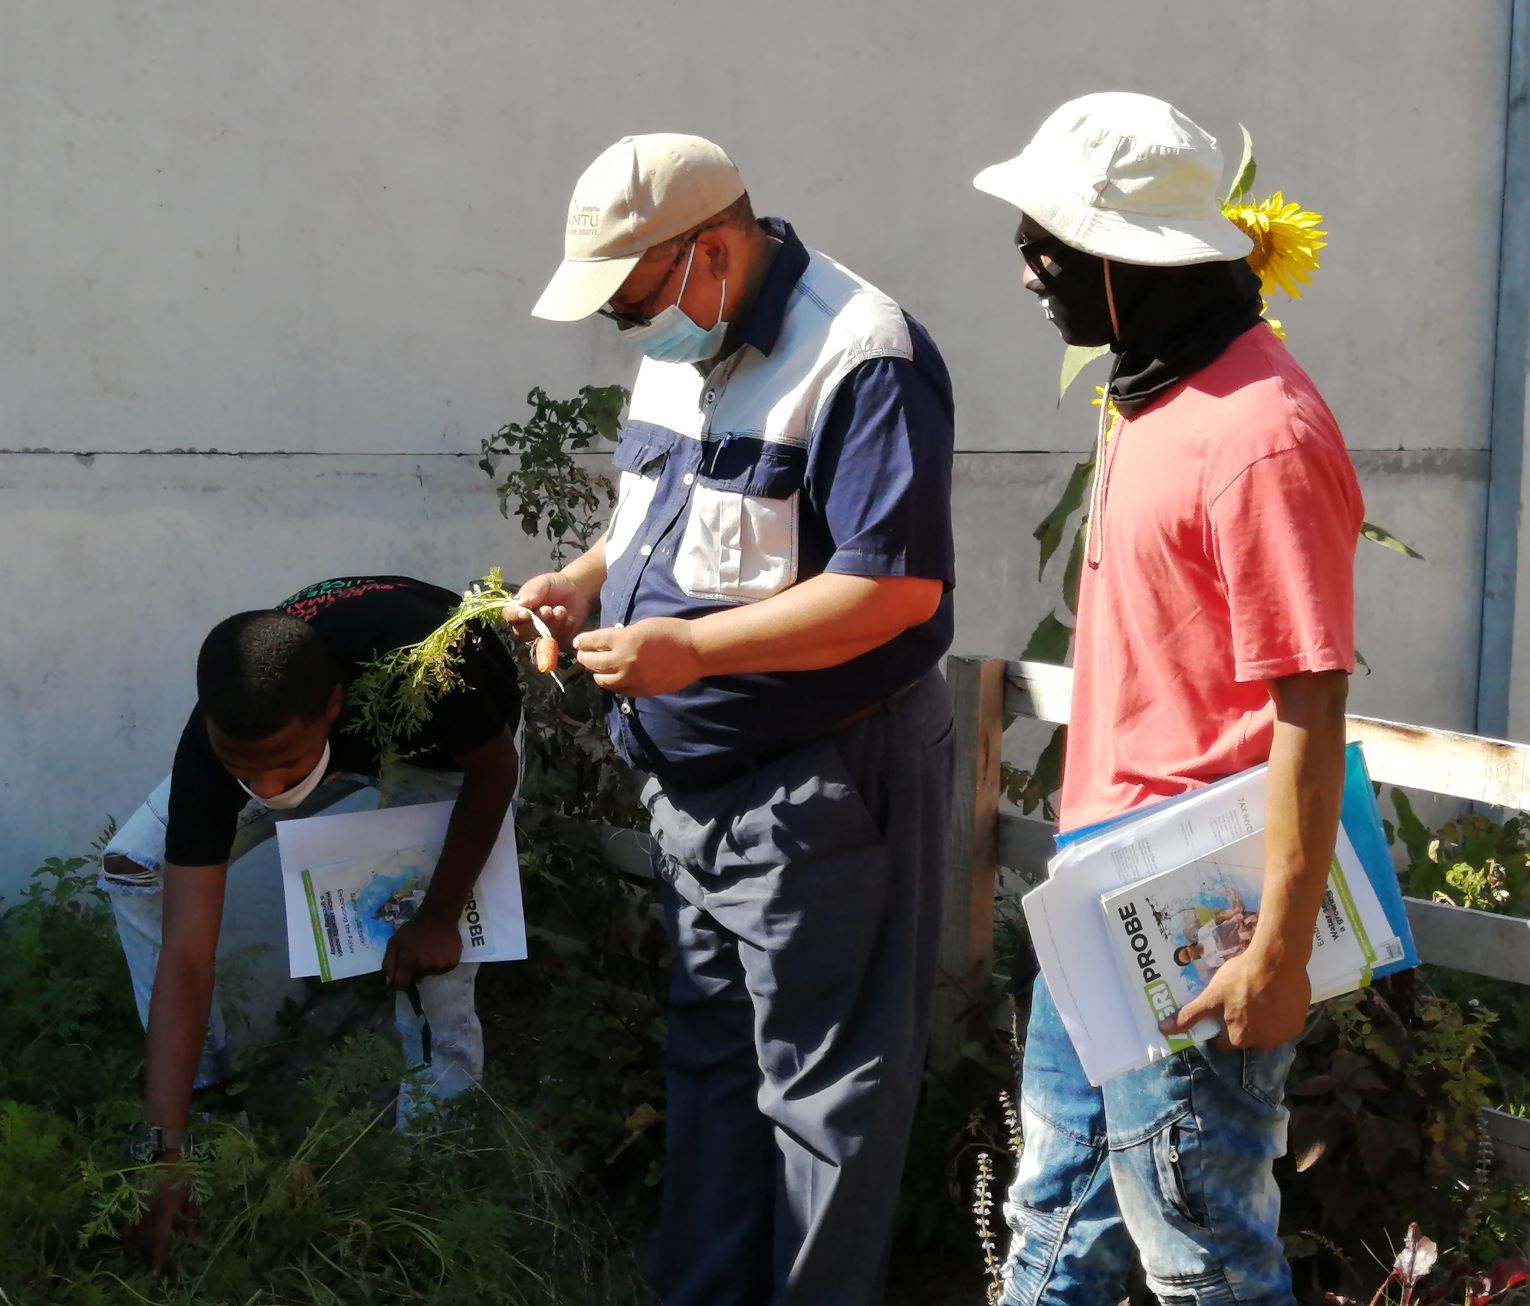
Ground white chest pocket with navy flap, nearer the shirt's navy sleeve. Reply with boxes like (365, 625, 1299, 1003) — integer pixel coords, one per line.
(675, 437, 808, 603)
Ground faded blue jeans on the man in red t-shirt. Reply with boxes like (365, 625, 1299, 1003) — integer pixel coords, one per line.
(1002, 979, 1296, 1306)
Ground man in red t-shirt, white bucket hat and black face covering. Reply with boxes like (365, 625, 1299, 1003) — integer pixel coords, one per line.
(976, 92, 1362, 1306)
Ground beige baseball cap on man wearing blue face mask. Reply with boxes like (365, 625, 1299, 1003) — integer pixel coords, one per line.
(531, 132, 744, 323)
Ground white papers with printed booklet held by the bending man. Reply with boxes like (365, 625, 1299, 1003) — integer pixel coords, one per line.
(277, 801, 526, 980)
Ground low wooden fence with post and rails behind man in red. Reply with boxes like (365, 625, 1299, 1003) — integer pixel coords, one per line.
(932, 656, 1530, 1181)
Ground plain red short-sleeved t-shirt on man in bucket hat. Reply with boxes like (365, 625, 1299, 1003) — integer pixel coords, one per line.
(1060, 323, 1362, 830)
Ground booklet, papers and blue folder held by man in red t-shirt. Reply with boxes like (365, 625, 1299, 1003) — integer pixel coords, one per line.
(1024, 745, 1418, 1086)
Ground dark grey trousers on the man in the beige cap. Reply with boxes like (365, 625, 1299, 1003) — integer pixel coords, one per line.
(643, 673, 952, 1306)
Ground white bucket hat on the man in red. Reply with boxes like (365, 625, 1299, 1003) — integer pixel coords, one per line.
(973, 90, 1253, 268)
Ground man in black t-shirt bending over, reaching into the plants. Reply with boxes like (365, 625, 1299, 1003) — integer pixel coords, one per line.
(101, 577, 520, 1268)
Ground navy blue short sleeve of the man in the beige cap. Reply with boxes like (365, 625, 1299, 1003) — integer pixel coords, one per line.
(806, 358, 956, 590)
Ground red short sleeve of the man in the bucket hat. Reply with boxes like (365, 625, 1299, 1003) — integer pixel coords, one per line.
(1209, 431, 1363, 681)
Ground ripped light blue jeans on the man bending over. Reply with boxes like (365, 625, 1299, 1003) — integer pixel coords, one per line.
(101, 765, 483, 1129)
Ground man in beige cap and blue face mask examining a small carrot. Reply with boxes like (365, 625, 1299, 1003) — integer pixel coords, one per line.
(509, 135, 955, 1306)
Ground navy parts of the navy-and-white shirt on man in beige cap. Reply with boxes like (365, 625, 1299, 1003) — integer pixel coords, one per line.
(601, 219, 956, 788)
